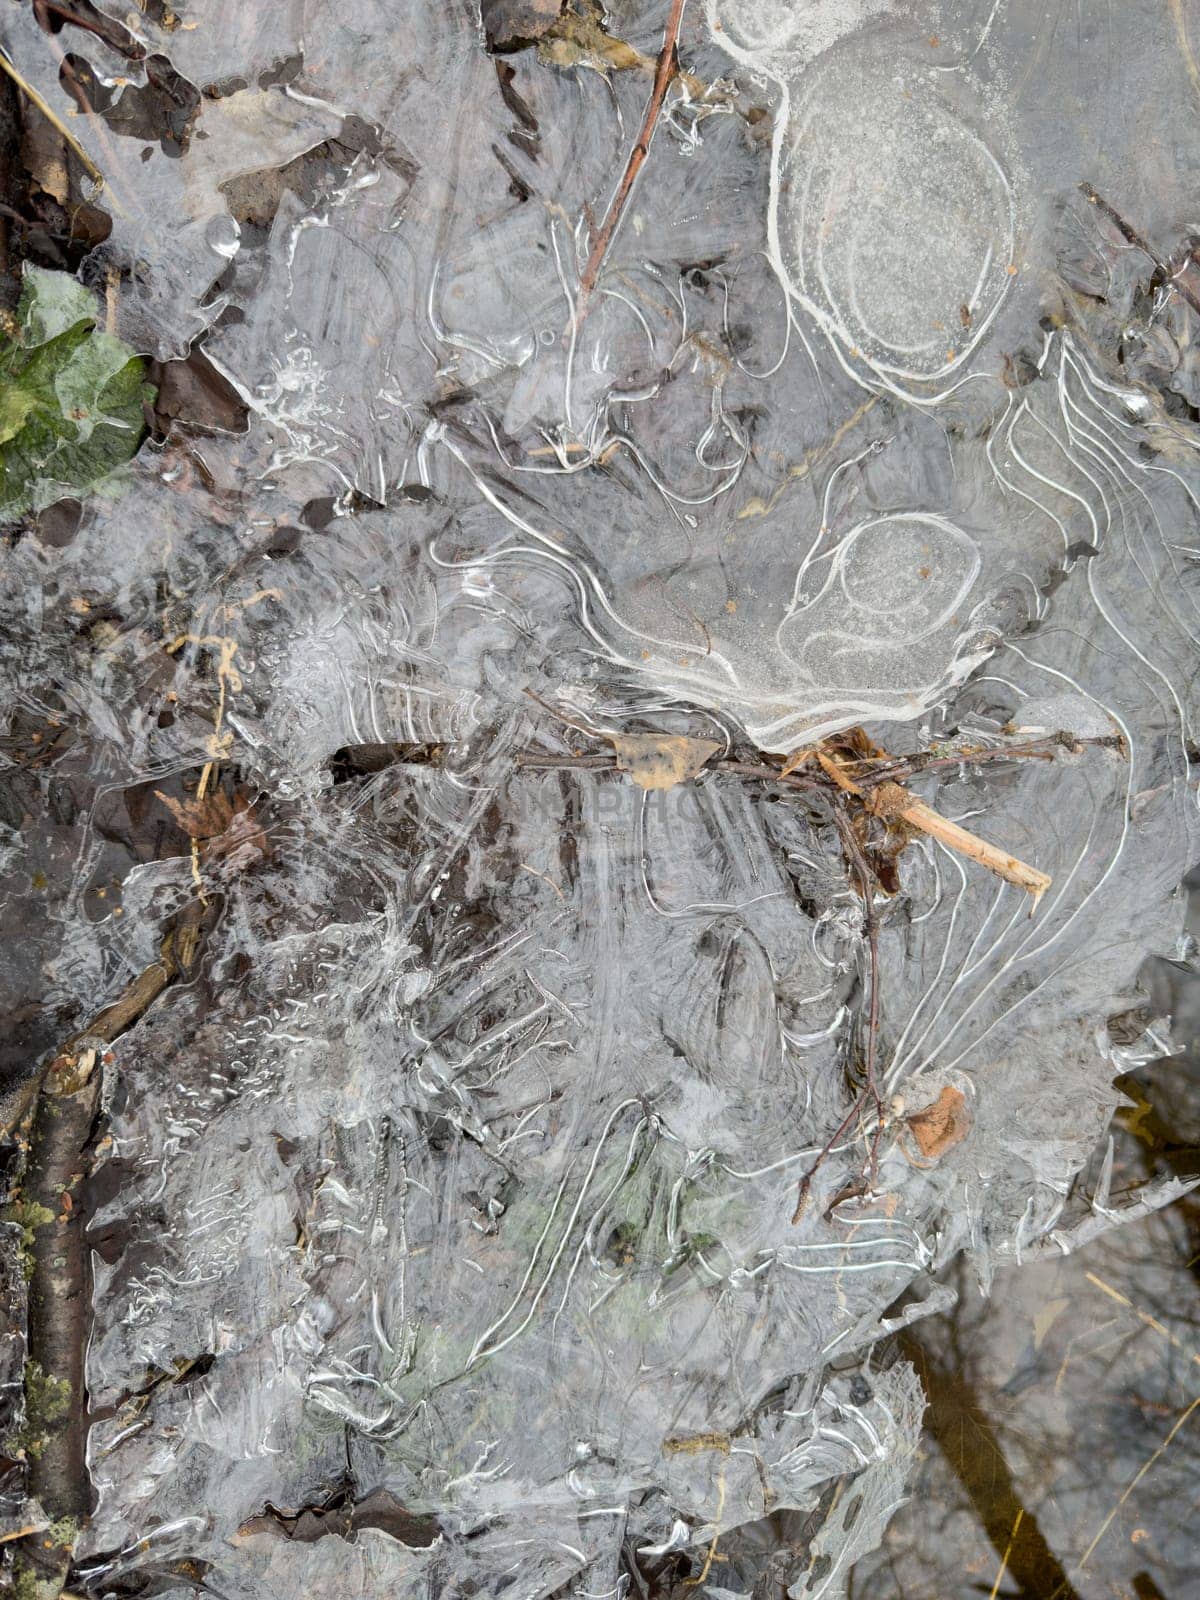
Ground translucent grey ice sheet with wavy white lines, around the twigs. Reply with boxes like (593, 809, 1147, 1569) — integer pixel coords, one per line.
(0, 0, 1200, 1600)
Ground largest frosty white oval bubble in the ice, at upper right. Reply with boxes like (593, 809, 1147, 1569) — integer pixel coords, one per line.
(773, 48, 1014, 386)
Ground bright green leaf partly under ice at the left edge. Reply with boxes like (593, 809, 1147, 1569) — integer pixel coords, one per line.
(0, 267, 155, 522)
